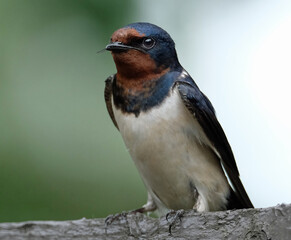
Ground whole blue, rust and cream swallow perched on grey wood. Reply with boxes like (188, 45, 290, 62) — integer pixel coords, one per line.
(105, 23, 253, 215)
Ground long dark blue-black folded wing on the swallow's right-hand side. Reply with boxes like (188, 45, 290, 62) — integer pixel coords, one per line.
(176, 76, 253, 208)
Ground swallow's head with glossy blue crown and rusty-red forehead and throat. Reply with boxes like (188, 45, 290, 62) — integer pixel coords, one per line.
(106, 23, 180, 79)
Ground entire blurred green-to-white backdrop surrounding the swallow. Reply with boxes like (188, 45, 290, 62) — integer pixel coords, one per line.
(0, 0, 291, 222)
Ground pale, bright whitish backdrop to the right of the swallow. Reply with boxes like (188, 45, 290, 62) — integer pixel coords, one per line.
(139, 0, 291, 207)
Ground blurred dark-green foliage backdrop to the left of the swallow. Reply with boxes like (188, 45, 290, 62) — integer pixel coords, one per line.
(0, 0, 146, 222)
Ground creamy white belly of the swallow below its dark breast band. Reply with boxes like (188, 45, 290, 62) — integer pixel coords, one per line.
(113, 90, 229, 211)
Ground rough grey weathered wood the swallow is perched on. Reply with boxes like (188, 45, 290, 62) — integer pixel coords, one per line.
(0, 204, 291, 240)
